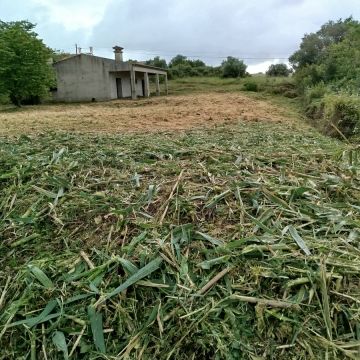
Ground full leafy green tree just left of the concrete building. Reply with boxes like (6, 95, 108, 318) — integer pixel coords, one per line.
(0, 21, 54, 106)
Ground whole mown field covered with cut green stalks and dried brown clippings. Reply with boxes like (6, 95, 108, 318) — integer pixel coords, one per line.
(0, 80, 360, 360)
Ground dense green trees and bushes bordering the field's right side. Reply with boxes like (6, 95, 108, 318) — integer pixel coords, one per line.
(290, 18, 360, 136)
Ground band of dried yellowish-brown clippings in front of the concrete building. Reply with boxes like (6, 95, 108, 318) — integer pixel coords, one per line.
(0, 93, 294, 135)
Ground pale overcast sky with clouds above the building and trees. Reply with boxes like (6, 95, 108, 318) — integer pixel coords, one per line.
(0, 0, 360, 72)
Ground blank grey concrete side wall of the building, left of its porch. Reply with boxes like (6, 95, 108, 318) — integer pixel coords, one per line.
(55, 55, 116, 101)
